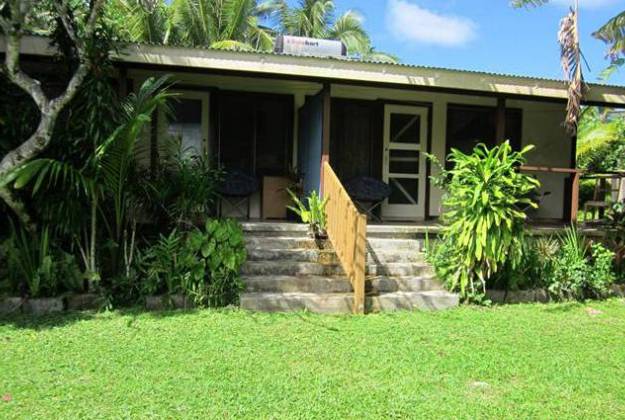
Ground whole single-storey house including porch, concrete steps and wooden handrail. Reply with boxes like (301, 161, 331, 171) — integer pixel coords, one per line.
(7, 36, 625, 313)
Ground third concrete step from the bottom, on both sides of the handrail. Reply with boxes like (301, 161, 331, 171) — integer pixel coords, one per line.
(241, 261, 433, 276)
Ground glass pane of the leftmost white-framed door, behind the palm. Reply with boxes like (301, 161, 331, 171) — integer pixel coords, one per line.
(167, 99, 203, 157)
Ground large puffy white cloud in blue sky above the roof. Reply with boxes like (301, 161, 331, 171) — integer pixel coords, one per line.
(386, 0, 477, 47)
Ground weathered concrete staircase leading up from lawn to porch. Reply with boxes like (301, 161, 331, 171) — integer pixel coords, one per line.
(241, 223, 458, 313)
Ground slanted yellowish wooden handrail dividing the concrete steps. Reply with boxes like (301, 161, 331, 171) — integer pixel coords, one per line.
(321, 161, 367, 314)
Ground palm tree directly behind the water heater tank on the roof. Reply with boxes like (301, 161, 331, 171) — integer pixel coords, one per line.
(261, 0, 398, 62)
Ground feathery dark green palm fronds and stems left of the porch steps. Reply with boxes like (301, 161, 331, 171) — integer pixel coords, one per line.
(9, 76, 171, 281)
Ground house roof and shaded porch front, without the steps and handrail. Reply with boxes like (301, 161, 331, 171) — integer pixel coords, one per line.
(8, 37, 625, 221)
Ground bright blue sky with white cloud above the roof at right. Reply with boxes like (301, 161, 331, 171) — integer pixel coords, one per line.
(324, 0, 625, 85)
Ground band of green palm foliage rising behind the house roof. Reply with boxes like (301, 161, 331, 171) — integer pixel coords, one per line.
(106, 0, 398, 62)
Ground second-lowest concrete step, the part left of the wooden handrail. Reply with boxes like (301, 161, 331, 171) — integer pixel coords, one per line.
(243, 276, 353, 293)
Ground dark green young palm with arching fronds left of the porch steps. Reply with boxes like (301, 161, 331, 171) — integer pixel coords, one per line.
(10, 77, 172, 283)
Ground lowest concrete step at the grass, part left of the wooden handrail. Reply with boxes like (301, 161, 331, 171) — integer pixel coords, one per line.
(241, 293, 354, 314)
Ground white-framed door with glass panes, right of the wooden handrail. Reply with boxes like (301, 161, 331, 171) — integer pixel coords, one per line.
(382, 105, 428, 220)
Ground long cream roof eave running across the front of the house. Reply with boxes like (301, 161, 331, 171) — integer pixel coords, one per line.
(0, 36, 625, 107)
